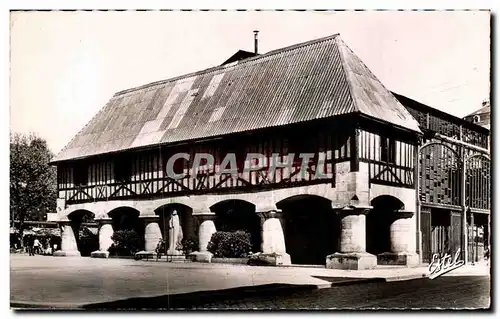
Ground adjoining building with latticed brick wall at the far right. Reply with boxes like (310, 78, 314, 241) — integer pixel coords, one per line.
(395, 94, 491, 262)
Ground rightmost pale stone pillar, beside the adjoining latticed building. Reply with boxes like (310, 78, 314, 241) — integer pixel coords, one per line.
(378, 211, 419, 267)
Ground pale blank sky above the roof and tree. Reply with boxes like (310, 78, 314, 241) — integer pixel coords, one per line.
(10, 11, 490, 153)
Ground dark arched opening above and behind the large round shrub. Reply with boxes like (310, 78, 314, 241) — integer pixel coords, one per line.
(210, 200, 261, 252)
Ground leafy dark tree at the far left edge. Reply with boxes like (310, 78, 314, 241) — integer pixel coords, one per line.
(10, 133, 57, 240)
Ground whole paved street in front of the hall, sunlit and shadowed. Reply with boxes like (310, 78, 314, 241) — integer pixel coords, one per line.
(10, 255, 490, 309)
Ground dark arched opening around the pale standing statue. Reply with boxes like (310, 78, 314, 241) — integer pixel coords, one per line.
(155, 204, 198, 253)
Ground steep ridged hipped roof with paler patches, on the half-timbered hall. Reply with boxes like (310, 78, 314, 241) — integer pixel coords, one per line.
(54, 34, 420, 162)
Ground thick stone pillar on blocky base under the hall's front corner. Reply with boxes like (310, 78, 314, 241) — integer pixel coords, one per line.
(326, 206, 377, 270)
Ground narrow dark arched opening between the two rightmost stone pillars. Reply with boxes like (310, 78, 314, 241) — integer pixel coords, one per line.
(366, 195, 404, 255)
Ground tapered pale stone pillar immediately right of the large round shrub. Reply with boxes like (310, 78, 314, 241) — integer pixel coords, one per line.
(257, 210, 292, 265)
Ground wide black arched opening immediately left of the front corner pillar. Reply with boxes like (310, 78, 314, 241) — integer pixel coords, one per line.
(276, 195, 340, 265)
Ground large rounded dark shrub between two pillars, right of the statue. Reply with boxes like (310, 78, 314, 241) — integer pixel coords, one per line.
(207, 230, 252, 258)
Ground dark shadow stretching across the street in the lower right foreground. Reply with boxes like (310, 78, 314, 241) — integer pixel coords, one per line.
(155, 276, 490, 310)
